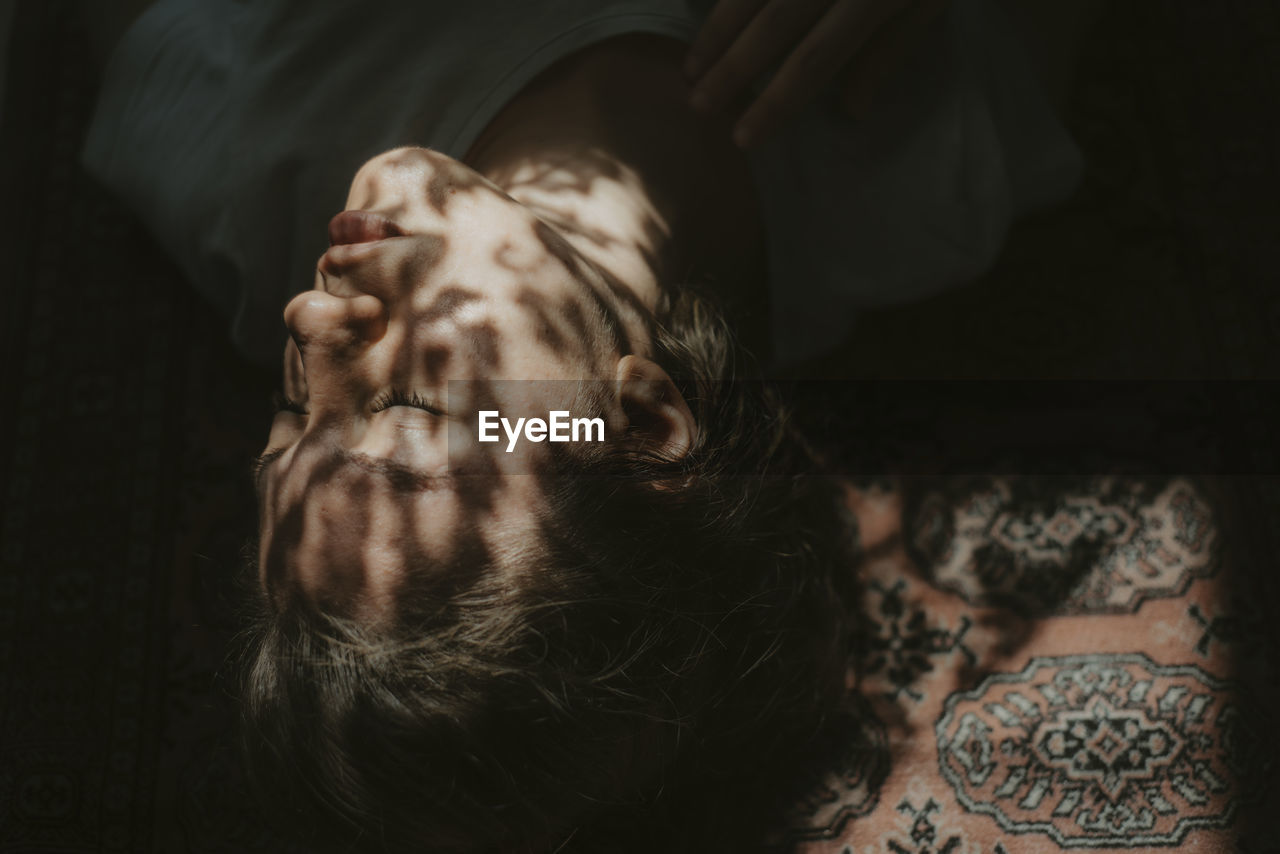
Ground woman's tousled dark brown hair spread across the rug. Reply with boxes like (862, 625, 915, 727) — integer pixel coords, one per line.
(241, 285, 852, 853)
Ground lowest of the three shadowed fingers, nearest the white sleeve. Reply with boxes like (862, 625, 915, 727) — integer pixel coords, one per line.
(733, 0, 901, 147)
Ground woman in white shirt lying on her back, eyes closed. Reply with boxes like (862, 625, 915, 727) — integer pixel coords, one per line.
(77, 3, 1070, 851)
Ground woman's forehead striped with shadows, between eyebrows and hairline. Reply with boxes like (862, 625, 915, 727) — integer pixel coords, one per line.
(259, 445, 541, 616)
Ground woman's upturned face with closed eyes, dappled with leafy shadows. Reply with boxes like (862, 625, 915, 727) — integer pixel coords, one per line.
(259, 149, 645, 613)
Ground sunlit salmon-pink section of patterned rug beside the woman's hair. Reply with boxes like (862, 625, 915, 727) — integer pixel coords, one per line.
(790, 476, 1280, 854)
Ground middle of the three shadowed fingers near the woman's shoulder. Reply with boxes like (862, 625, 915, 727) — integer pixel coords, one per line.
(692, 0, 829, 110)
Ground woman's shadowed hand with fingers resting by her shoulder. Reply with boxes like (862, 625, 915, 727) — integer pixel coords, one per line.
(685, 0, 947, 149)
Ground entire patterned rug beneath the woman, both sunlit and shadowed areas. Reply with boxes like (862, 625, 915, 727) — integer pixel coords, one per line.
(0, 0, 1280, 854)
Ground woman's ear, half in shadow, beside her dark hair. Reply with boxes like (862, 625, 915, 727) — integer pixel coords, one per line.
(616, 355, 698, 460)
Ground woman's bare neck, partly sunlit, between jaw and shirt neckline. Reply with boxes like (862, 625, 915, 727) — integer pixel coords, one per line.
(465, 36, 764, 345)
